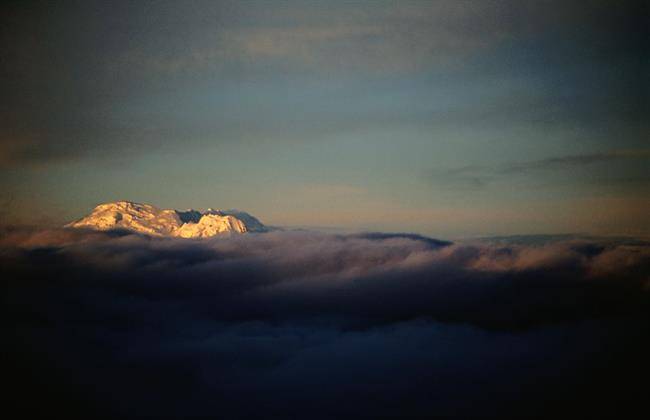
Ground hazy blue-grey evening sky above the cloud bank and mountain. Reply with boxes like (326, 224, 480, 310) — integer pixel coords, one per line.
(0, 1, 650, 238)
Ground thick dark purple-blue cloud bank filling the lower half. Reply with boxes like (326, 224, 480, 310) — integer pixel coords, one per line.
(0, 230, 650, 418)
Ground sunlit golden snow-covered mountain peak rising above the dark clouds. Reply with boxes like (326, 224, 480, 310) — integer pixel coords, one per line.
(66, 201, 268, 238)
